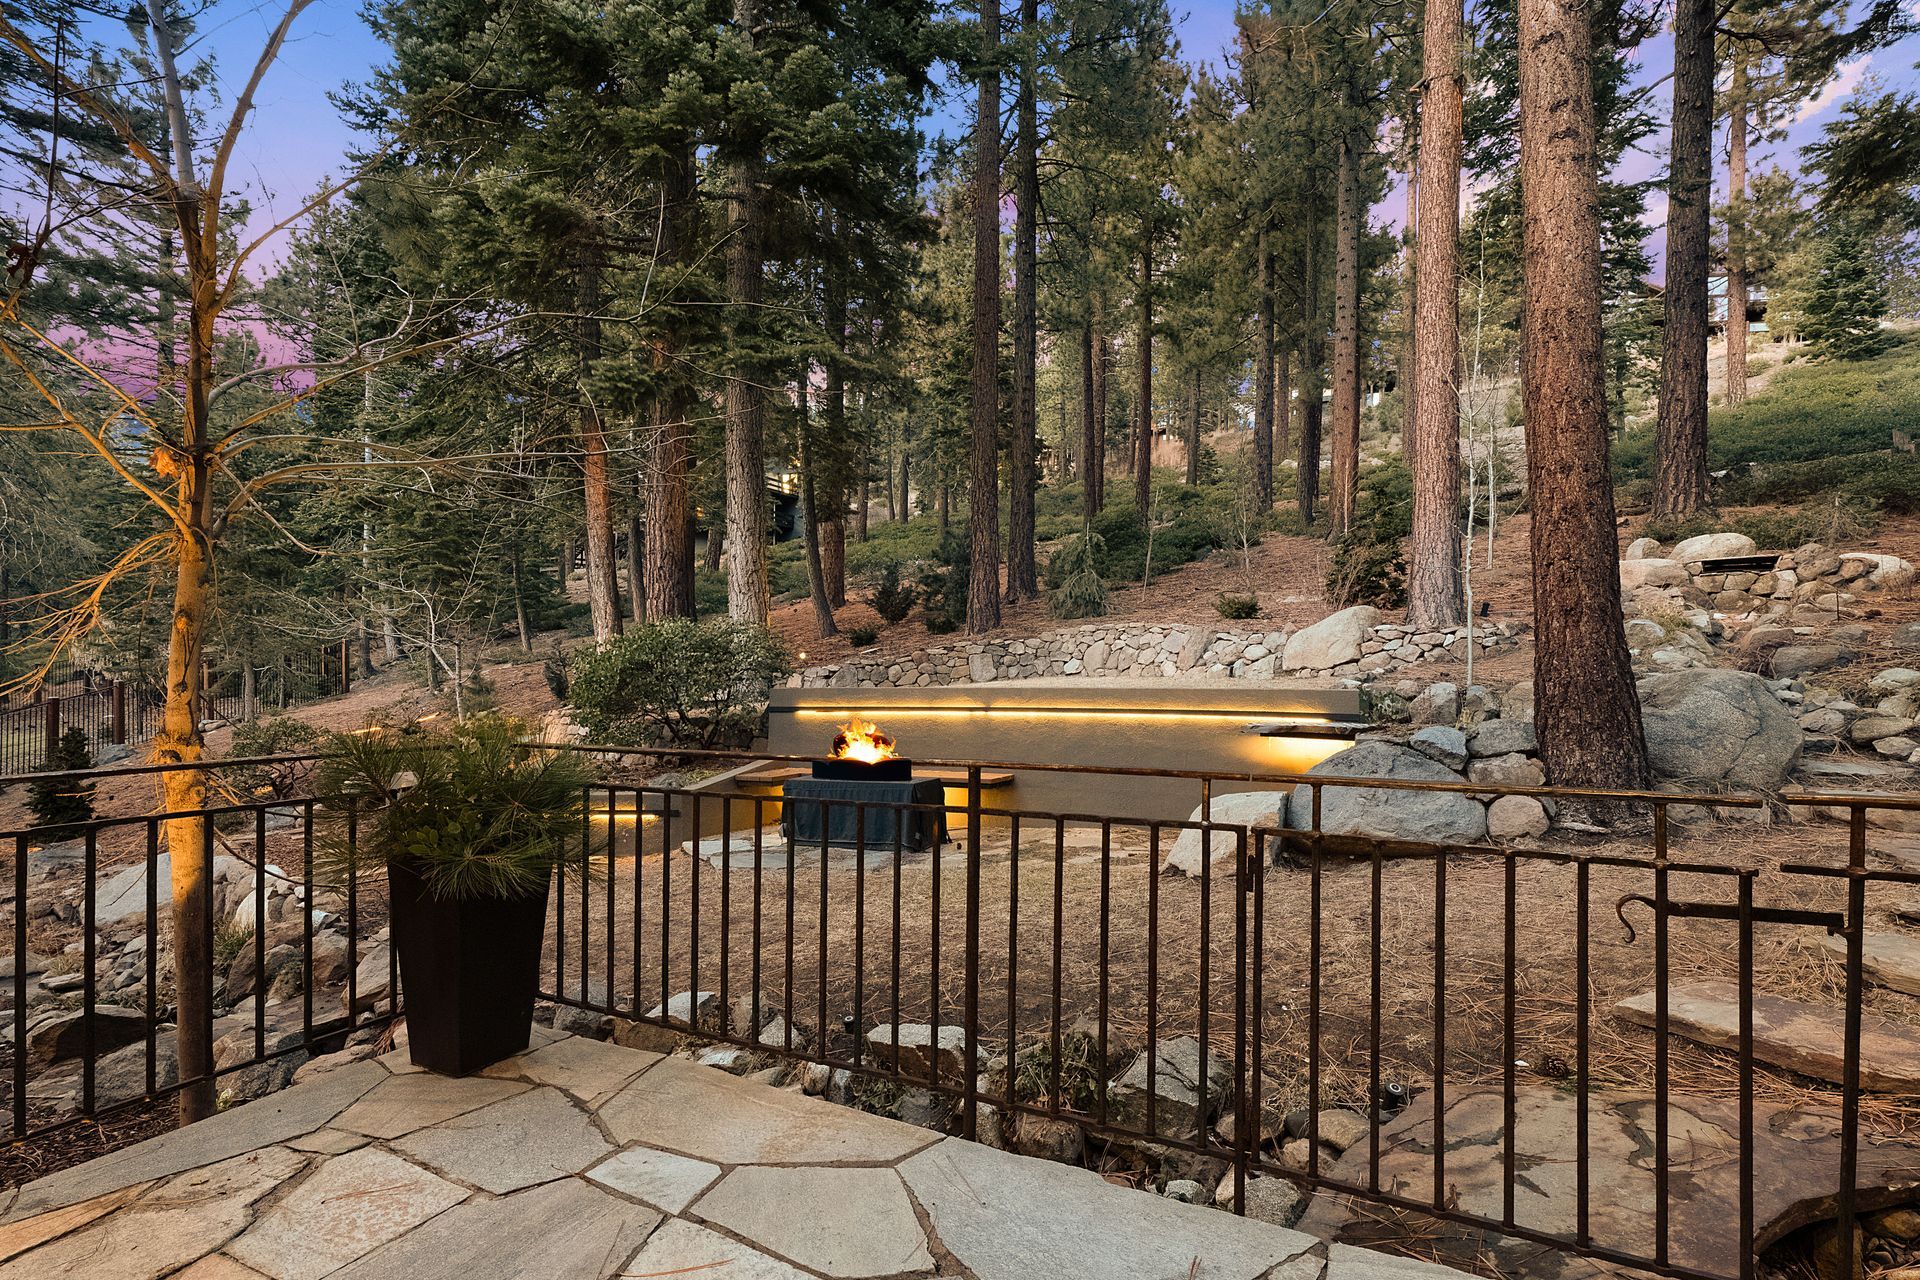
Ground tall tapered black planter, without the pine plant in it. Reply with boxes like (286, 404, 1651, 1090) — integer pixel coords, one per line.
(388, 865, 547, 1075)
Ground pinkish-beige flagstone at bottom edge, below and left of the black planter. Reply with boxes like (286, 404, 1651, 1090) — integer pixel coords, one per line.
(227, 1143, 468, 1280)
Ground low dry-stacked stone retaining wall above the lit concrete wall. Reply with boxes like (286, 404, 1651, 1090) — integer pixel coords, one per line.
(793, 608, 1523, 689)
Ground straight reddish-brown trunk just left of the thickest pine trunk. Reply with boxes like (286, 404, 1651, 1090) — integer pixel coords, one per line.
(1405, 0, 1467, 631)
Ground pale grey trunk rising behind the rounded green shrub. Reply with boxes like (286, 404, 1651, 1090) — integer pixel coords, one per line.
(726, 0, 772, 626)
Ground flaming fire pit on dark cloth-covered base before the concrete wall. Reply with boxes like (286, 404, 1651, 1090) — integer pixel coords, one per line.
(780, 716, 947, 852)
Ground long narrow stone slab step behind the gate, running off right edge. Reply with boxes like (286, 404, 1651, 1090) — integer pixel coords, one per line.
(1613, 983, 1920, 1094)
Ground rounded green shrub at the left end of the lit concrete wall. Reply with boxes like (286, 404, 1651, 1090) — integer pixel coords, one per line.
(572, 618, 793, 747)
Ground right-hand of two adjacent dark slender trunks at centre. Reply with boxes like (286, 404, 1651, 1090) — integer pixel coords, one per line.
(1006, 0, 1041, 601)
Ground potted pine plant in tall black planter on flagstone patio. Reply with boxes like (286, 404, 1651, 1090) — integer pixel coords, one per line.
(315, 716, 593, 1075)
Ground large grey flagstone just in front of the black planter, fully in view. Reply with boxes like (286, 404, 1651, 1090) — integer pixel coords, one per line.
(394, 1088, 612, 1196)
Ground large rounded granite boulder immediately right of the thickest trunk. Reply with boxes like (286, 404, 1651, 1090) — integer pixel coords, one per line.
(1640, 670, 1801, 791)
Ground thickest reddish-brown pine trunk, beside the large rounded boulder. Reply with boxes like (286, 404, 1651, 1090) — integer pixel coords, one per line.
(1521, 0, 1647, 787)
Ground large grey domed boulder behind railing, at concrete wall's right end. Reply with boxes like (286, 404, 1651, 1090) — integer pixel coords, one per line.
(1286, 743, 1486, 844)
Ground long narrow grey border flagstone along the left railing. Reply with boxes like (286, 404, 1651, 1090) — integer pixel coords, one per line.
(6, 1063, 388, 1222)
